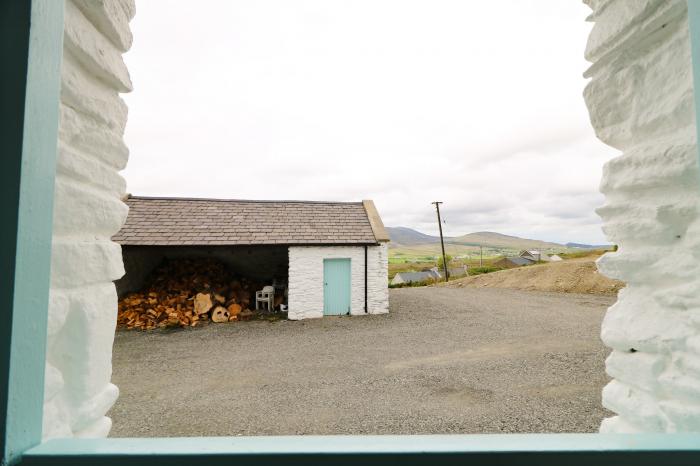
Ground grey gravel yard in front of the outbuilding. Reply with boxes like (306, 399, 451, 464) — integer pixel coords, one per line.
(110, 288, 614, 437)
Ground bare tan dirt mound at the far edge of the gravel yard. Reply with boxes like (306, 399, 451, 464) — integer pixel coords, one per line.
(440, 259, 625, 294)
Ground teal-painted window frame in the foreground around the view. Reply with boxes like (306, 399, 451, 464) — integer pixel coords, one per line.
(0, 0, 700, 466)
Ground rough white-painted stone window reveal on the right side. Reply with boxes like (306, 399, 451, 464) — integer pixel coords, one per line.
(585, 0, 700, 432)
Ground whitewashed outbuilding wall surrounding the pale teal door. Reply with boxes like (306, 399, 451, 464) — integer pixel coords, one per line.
(288, 243, 389, 320)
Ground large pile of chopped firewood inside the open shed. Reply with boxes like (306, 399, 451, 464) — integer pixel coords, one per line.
(117, 259, 261, 330)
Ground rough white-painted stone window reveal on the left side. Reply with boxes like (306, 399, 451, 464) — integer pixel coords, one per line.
(44, 0, 134, 438)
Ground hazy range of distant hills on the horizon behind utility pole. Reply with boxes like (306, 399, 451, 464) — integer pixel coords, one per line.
(387, 227, 564, 249)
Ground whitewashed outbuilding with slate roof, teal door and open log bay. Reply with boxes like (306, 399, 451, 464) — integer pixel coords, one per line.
(112, 196, 389, 320)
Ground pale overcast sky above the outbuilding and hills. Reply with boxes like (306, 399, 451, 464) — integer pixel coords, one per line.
(123, 0, 617, 244)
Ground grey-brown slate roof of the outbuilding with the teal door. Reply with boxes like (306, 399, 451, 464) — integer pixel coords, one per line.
(112, 196, 378, 246)
